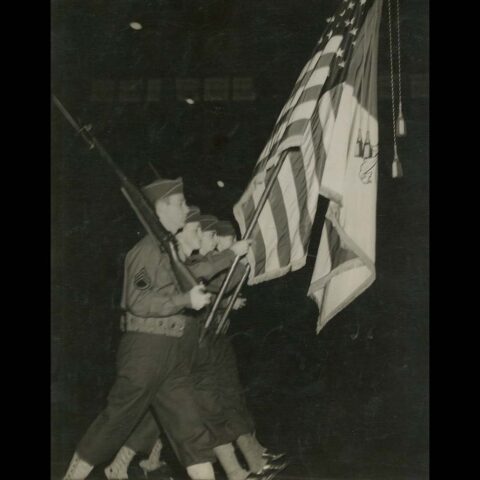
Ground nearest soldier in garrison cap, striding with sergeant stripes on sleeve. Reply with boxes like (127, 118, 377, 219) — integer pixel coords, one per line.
(65, 179, 220, 480)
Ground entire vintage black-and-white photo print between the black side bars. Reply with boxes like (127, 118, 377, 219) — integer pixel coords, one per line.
(50, 0, 429, 480)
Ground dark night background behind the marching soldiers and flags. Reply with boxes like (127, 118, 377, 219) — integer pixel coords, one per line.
(51, 0, 429, 480)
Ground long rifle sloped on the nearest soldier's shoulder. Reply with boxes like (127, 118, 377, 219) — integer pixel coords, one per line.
(53, 95, 198, 293)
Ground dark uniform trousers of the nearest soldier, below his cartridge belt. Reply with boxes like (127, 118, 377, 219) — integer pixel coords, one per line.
(77, 319, 216, 467)
